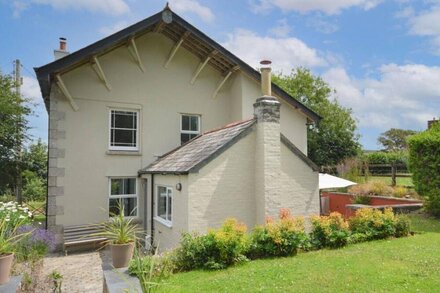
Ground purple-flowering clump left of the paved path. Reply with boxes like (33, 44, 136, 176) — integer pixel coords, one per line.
(16, 225, 55, 261)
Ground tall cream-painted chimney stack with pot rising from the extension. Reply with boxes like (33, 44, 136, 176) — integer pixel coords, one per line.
(254, 60, 281, 224)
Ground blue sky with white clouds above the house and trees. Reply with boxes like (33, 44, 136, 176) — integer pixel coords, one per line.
(0, 0, 440, 149)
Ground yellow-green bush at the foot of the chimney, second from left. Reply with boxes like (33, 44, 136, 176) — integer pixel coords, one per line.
(248, 209, 308, 258)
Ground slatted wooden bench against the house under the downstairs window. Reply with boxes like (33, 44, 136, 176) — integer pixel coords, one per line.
(64, 224, 107, 253)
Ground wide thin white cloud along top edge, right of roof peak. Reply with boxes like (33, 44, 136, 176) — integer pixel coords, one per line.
(251, 0, 383, 14)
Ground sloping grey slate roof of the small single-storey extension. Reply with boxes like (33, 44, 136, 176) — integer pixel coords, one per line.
(139, 118, 256, 174)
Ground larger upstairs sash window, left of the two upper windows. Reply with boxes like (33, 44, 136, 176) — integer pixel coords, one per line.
(109, 110, 139, 151)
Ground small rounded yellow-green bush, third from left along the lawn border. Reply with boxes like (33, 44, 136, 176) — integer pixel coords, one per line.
(310, 212, 350, 249)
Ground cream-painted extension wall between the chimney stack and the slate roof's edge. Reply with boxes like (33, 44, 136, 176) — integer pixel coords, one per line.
(188, 126, 256, 233)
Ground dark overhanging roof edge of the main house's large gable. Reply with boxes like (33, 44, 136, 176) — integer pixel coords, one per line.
(34, 6, 321, 122)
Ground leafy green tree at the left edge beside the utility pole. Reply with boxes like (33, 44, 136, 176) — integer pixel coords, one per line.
(0, 72, 31, 193)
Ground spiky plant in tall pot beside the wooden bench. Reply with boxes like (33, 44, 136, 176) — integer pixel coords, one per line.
(96, 205, 141, 268)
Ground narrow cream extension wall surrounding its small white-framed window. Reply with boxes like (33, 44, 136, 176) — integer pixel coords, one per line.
(154, 175, 188, 251)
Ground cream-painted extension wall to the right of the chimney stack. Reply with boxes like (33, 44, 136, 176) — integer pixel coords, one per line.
(281, 143, 320, 217)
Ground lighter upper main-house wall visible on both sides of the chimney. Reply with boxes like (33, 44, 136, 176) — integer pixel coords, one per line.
(241, 75, 307, 155)
